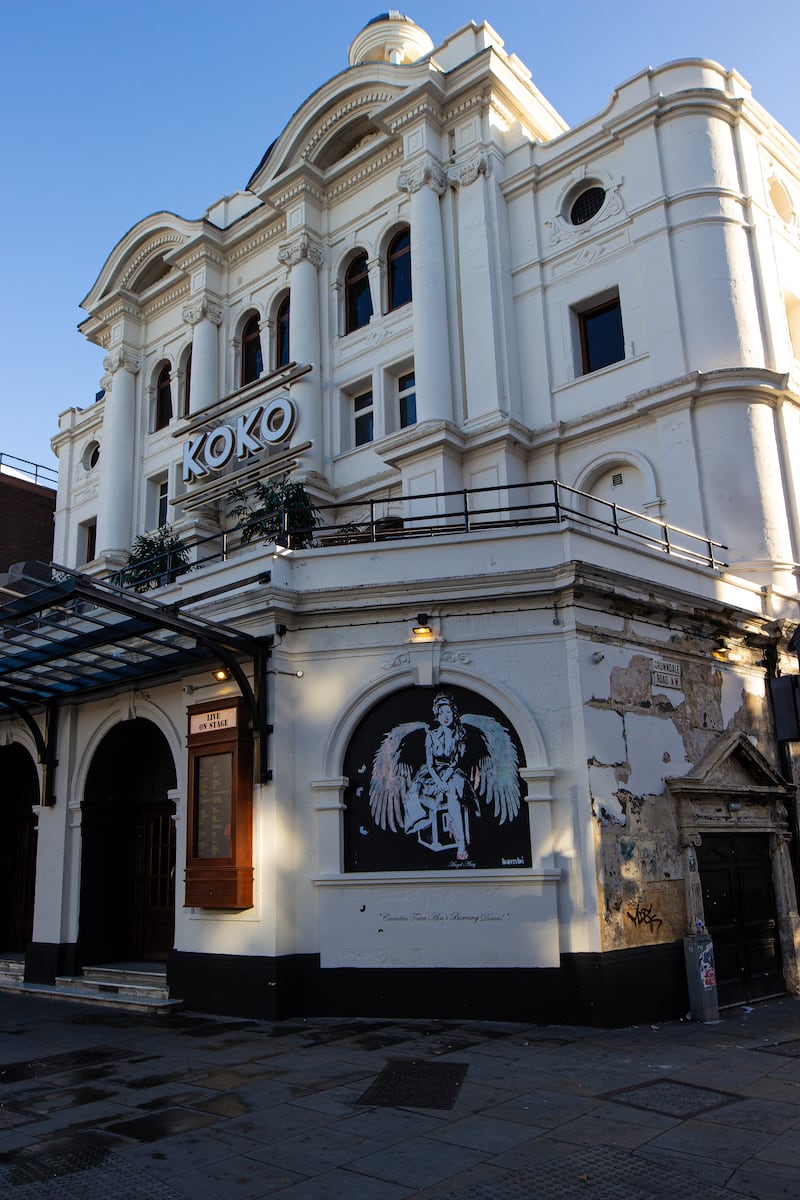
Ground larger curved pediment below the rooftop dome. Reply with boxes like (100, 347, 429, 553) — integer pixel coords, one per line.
(247, 62, 429, 194)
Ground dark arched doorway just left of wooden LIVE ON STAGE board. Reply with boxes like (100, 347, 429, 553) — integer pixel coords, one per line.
(78, 719, 175, 965)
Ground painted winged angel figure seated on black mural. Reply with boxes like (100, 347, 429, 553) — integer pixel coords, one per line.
(369, 691, 519, 863)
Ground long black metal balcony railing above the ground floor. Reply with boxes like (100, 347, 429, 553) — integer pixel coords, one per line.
(109, 480, 728, 590)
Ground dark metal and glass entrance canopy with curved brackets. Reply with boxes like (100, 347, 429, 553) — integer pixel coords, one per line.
(0, 563, 272, 804)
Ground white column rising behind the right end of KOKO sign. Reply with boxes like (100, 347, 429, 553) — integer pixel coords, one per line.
(278, 234, 323, 474)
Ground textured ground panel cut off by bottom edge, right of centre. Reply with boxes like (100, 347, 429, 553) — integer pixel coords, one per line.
(447, 1147, 730, 1200)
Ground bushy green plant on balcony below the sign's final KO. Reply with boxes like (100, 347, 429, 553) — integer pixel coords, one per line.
(228, 478, 321, 550)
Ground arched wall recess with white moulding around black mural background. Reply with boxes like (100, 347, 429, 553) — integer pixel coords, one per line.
(312, 665, 554, 874)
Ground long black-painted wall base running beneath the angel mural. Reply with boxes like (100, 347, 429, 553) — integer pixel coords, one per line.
(167, 942, 688, 1027)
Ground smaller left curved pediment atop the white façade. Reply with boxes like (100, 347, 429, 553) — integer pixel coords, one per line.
(80, 212, 203, 312)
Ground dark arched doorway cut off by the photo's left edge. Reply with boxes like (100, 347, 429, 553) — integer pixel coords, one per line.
(0, 745, 38, 954)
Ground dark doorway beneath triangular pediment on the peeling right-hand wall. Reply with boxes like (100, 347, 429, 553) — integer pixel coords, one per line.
(698, 833, 784, 1004)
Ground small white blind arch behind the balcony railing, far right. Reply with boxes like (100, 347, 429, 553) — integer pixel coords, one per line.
(575, 450, 663, 536)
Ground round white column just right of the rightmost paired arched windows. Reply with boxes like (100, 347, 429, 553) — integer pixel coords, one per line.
(397, 158, 452, 421)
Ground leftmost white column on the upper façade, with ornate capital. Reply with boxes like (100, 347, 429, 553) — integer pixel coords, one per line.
(97, 347, 139, 557)
